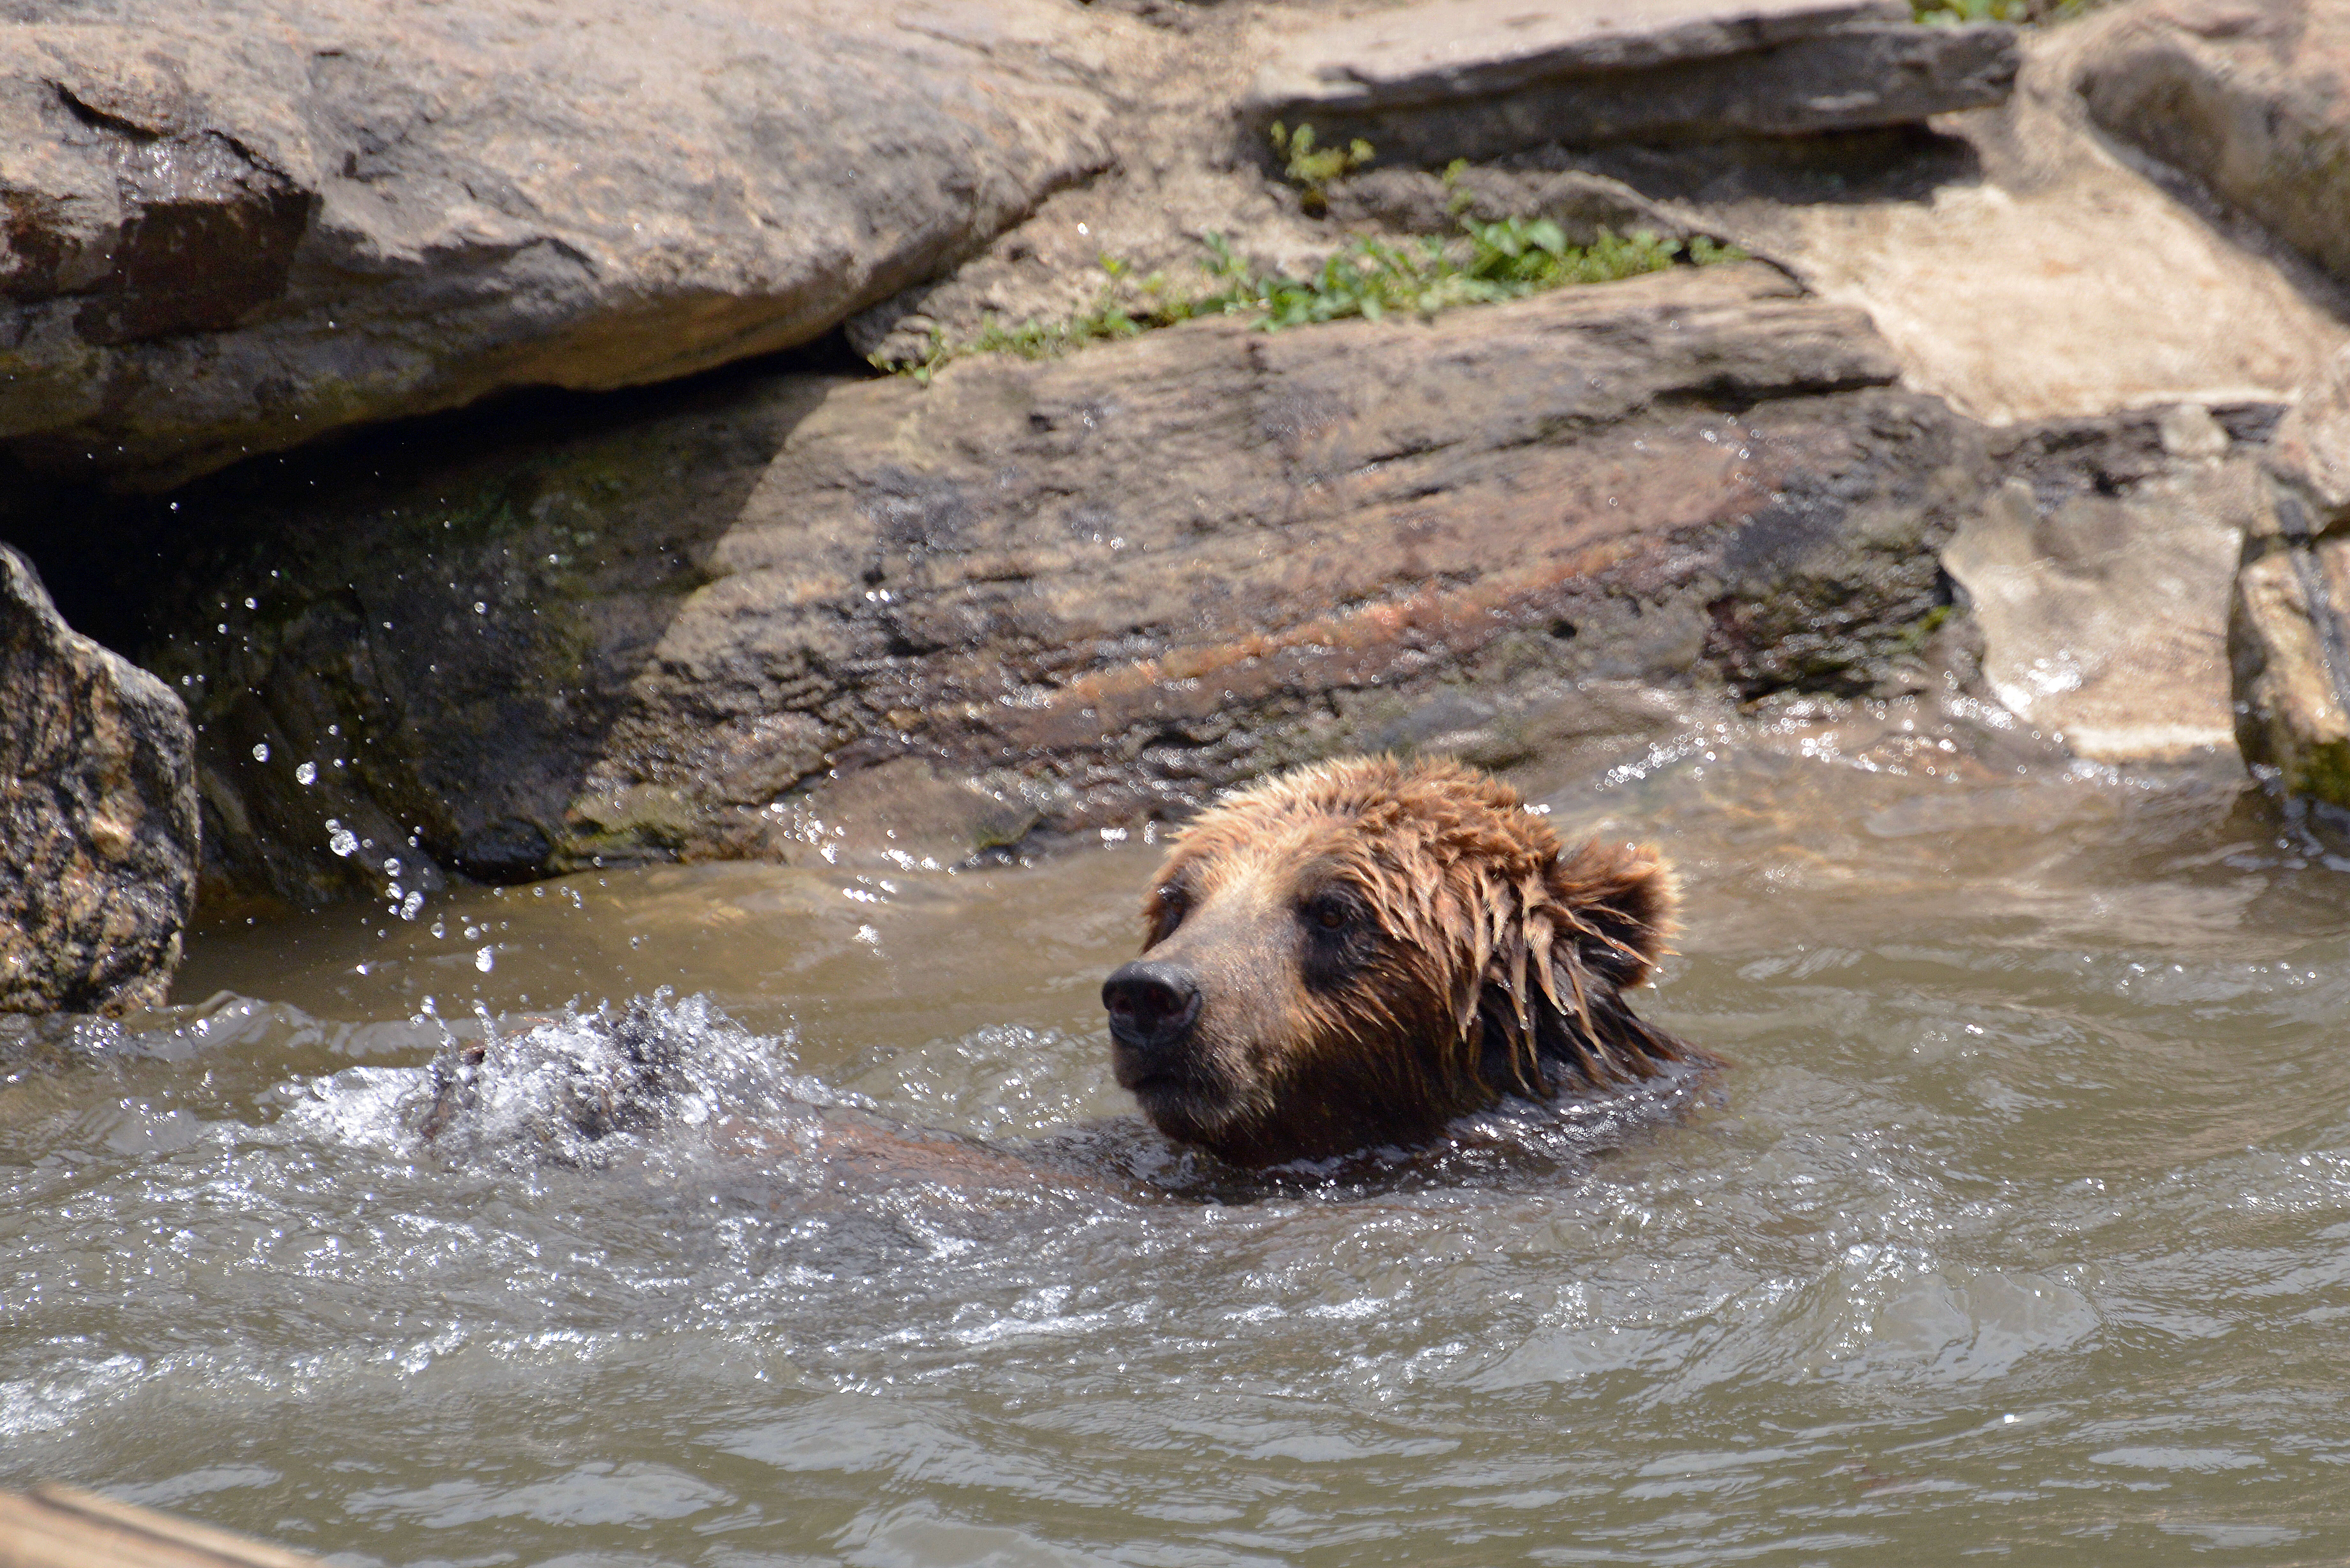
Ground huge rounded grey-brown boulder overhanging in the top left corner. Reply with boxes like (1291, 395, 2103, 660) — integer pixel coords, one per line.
(0, 0, 1118, 486)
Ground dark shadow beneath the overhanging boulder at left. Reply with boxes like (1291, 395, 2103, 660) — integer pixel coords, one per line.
(35, 362, 825, 910)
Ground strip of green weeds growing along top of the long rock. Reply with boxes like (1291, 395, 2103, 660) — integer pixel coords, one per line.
(876, 216, 1746, 383)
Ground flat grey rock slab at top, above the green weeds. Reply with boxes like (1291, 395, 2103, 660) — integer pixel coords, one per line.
(1243, 0, 2016, 165)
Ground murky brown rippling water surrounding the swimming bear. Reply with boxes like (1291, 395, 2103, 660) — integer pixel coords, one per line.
(0, 714, 2350, 1566)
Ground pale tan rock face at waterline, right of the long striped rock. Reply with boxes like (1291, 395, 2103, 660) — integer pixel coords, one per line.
(1941, 404, 2265, 762)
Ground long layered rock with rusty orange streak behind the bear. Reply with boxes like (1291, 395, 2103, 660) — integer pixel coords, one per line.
(124, 266, 1983, 898)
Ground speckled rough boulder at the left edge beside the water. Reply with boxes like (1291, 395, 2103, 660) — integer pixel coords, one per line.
(0, 546, 197, 1013)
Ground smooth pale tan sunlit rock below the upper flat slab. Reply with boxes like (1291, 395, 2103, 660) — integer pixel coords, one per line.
(1699, 17, 2350, 426)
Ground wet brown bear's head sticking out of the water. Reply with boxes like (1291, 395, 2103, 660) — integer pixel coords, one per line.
(1102, 757, 1709, 1166)
